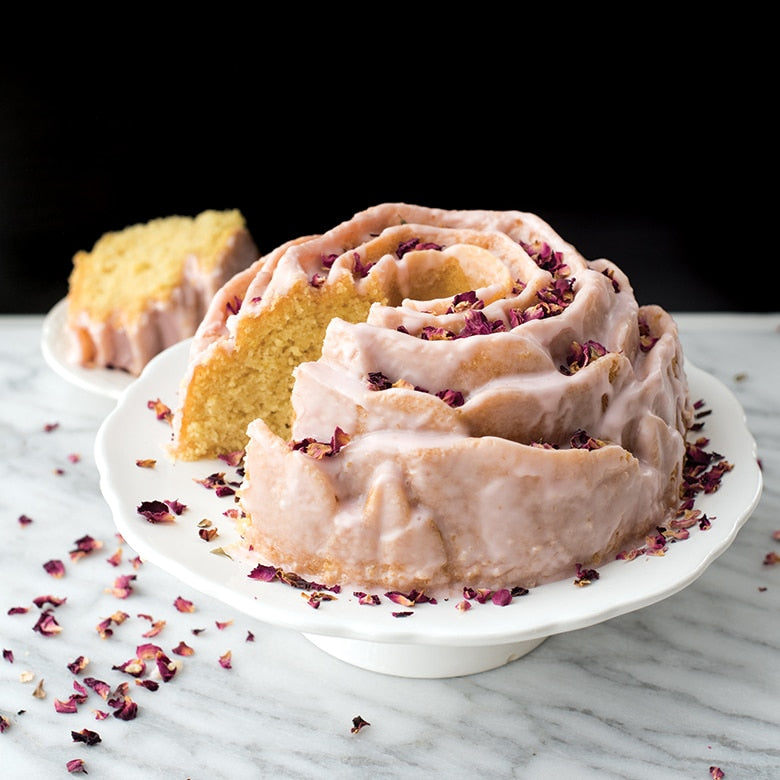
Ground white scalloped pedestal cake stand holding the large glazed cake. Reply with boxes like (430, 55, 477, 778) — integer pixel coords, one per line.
(95, 340, 762, 677)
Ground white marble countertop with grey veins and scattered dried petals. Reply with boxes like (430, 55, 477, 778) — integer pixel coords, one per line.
(0, 314, 780, 780)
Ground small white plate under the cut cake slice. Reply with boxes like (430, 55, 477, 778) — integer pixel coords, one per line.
(41, 298, 135, 398)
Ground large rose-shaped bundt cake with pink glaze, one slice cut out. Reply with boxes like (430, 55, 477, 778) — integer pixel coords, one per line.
(173, 203, 691, 592)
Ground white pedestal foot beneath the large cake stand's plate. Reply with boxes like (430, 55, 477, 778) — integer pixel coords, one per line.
(303, 633, 547, 679)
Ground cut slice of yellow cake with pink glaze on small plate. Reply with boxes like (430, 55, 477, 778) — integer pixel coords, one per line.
(66, 210, 260, 375)
